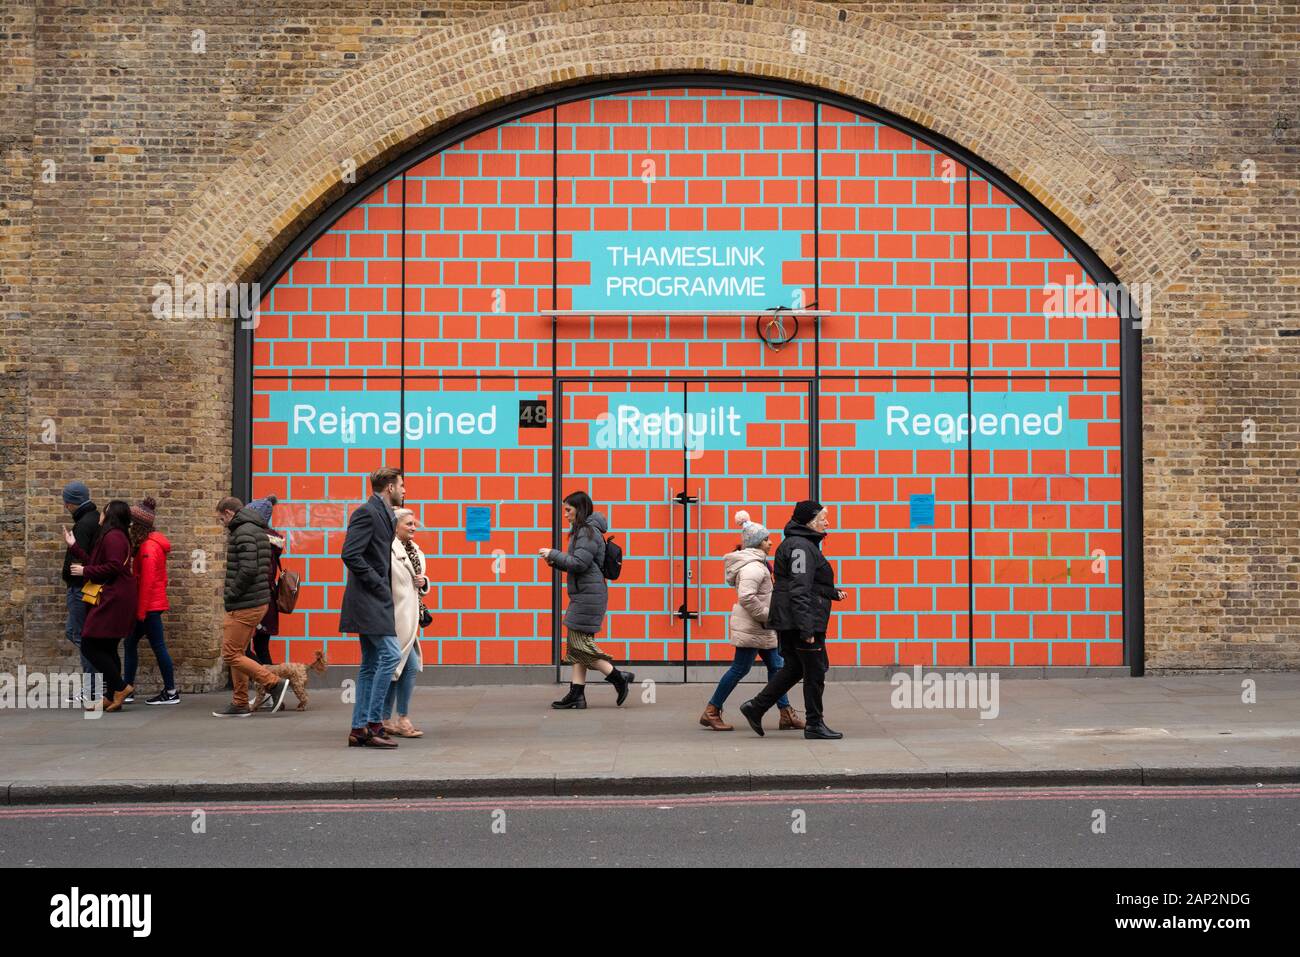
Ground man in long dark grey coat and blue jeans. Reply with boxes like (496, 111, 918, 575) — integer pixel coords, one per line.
(338, 468, 406, 748)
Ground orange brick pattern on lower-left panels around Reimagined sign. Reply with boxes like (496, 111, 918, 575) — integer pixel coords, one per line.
(254, 376, 551, 664)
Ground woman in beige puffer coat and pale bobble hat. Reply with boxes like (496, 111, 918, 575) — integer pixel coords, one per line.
(699, 511, 803, 731)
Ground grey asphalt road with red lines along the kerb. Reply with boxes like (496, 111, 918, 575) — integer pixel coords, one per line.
(0, 785, 1300, 867)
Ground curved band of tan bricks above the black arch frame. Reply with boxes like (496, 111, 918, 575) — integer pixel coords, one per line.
(155, 0, 1192, 289)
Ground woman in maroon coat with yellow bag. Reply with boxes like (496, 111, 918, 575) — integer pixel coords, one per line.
(64, 499, 137, 711)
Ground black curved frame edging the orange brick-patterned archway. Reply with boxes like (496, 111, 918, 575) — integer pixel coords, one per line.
(231, 72, 1145, 677)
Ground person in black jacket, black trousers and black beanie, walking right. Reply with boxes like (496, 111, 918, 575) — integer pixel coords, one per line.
(740, 501, 846, 740)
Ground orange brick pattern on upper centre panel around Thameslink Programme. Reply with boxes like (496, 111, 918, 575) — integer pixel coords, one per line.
(556, 88, 814, 376)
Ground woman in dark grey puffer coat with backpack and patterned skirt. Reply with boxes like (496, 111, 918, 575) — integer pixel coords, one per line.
(538, 492, 636, 709)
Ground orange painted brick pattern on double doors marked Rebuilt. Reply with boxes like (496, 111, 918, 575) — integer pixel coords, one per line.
(562, 381, 810, 662)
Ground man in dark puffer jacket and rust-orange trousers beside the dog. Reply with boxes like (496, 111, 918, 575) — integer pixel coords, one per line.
(212, 497, 289, 718)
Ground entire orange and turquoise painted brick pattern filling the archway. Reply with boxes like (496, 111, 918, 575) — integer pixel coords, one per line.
(255, 90, 1122, 664)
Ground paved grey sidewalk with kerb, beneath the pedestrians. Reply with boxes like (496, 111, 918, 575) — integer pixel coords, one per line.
(0, 674, 1300, 804)
